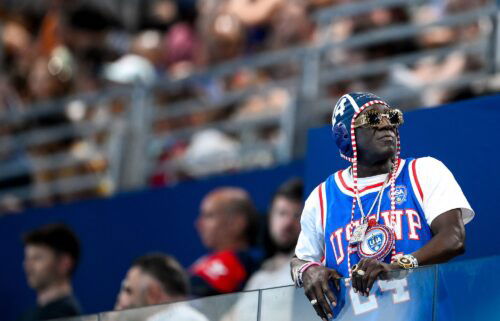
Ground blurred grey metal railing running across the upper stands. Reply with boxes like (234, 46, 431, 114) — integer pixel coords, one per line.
(0, 0, 500, 211)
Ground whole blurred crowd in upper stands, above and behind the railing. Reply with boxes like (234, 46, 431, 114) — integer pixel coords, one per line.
(0, 0, 492, 212)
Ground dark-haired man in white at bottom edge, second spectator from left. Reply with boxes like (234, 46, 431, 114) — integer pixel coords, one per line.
(115, 253, 207, 321)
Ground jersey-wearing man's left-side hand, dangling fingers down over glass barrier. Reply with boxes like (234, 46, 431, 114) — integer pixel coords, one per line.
(302, 266, 342, 320)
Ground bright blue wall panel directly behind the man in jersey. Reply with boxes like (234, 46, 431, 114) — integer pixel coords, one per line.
(305, 95, 500, 259)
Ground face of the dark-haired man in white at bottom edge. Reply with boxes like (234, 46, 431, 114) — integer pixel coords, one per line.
(115, 267, 149, 310)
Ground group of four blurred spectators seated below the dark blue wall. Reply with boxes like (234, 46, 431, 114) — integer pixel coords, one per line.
(18, 178, 304, 321)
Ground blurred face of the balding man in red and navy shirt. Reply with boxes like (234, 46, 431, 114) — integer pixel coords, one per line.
(196, 196, 233, 249)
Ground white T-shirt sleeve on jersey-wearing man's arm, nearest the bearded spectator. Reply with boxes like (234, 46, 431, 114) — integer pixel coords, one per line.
(295, 185, 324, 262)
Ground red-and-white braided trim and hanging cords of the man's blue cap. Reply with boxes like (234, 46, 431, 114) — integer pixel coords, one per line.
(340, 100, 400, 278)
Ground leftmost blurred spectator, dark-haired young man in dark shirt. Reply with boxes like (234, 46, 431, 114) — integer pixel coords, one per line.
(19, 224, 81, 321)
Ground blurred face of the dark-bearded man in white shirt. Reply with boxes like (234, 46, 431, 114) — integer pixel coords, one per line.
(269, 196, 302, 252)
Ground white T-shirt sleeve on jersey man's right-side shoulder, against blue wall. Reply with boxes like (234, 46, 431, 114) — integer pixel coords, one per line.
(414, 157, 474, 226)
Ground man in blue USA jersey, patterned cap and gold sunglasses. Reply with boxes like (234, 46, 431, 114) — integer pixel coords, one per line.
(291, 93, 474, 319)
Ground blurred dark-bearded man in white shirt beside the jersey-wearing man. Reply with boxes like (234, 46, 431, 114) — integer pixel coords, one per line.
(223, 178, 304, 321)
